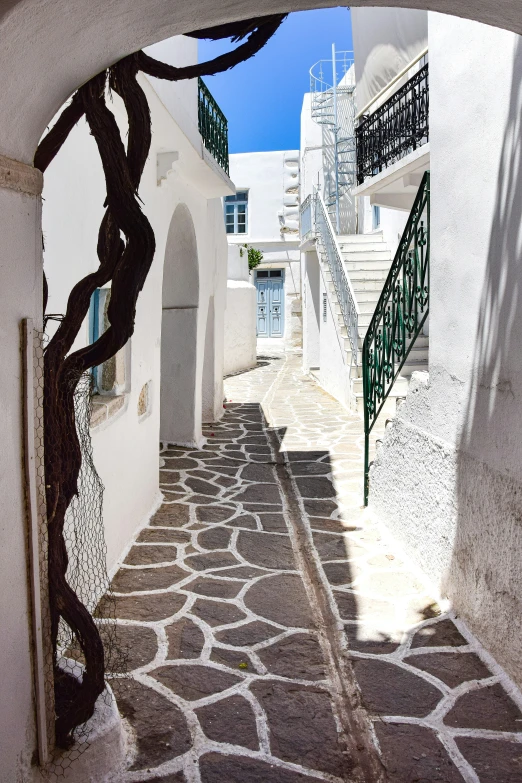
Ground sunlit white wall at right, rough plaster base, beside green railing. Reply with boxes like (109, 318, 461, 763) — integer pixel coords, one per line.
(370, 14, 522, 683)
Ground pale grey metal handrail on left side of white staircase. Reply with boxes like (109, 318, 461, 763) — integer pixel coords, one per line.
(300, 191, 359, 358)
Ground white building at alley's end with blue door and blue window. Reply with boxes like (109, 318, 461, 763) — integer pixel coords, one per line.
(225, 150, 302, 349)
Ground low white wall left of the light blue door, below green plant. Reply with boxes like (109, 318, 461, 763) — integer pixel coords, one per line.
(223, 245, 256, 375)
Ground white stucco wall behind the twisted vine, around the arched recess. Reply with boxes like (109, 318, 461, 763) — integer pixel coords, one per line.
(40, 33, 230, 567)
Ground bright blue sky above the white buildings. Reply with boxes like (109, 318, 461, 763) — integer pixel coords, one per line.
(199, 8, 353, 152)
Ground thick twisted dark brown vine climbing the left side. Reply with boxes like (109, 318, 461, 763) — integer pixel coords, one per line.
(34, 14, 286, 747)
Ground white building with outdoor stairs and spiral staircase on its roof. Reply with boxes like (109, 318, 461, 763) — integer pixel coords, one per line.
(300, 37, 427, 413)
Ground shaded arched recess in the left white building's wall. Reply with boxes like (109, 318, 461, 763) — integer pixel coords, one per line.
(160, 204, 199, 443)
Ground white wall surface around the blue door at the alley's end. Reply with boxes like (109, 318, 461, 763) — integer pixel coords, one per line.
(227, 150, 302, 349)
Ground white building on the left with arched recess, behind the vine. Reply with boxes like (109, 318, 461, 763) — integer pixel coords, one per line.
(43, 36, 234, 596)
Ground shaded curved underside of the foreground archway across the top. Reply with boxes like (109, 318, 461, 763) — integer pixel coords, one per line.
(0, 0, 522, 163)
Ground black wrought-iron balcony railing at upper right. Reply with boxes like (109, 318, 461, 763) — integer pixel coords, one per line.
(355, 64, 429, 185)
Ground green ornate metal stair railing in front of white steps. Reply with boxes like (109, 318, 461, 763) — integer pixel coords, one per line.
(362, 171, 430, 506)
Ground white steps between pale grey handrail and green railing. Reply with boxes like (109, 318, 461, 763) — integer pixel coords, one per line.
(318, 232, 428, 412)
